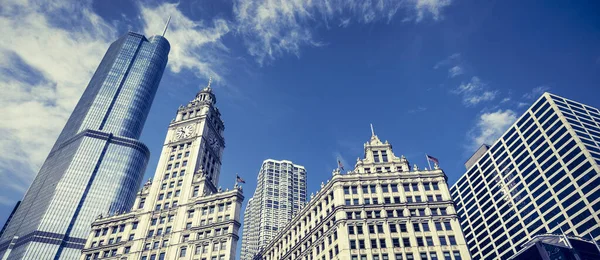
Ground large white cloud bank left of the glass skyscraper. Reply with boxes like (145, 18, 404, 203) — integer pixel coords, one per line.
(0, 1, 115, 199)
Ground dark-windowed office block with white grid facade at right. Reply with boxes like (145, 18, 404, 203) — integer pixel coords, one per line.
(451, 93, 600, 259)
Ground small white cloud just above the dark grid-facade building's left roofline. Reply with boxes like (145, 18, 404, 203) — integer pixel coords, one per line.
(467, 109, 517, 151)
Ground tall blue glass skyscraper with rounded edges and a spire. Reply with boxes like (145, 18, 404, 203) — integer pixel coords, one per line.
(0, 32, 170, 259)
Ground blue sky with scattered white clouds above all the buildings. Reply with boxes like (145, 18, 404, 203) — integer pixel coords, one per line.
(0, 0, 600, 247)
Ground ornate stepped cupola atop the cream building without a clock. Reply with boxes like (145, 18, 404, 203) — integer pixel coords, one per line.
(354, 125, 410, 173)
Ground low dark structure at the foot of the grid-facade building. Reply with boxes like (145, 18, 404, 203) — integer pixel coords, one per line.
(509, 234, 600, 260)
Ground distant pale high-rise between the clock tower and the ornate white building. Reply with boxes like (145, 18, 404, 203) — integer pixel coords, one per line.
(241, 159, 306, 260)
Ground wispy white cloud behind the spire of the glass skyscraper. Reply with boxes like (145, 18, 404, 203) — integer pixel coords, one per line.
(140, 3, 231, 81)
